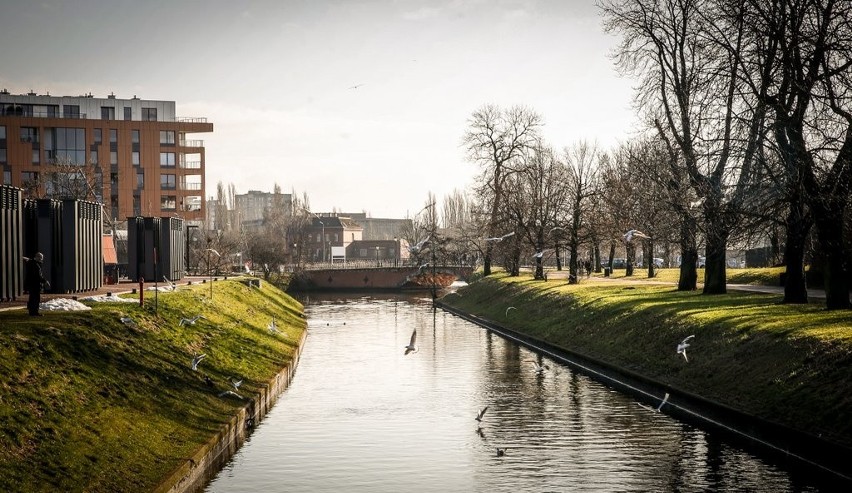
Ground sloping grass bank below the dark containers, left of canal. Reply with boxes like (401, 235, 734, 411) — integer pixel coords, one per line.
(0, 280, 305, 492)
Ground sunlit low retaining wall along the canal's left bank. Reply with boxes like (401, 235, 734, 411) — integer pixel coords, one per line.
(154, 329, 308, 493)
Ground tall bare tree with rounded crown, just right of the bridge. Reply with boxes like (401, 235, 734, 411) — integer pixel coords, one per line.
(463, 105, 542, 276)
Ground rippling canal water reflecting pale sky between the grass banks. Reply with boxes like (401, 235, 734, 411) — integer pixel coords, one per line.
(205, 295, 832, 493)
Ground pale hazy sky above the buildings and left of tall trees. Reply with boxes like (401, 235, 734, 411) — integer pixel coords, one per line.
(0, 0, 636, 218)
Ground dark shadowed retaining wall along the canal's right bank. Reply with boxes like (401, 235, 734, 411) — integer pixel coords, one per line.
(437, 301, 852, 482)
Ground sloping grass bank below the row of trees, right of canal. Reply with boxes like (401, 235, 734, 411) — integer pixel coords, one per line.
(442, 274, 852, 446)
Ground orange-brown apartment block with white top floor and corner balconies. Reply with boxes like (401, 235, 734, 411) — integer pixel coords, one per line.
(0, 90, 213, 221)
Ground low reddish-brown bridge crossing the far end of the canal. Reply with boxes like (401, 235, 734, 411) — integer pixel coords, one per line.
(290, 264, 475, 291)
